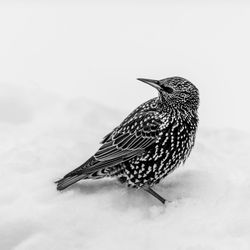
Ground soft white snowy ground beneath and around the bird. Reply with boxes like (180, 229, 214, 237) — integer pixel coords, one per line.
(0, 85, 250, 250)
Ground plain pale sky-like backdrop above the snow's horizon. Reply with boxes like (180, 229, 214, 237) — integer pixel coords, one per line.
(0, 0, 250, 130)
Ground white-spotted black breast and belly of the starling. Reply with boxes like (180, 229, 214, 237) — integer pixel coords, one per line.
(114, 103, 198, 188)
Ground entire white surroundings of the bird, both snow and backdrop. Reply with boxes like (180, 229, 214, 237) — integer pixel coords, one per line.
(0, 0, 250, 250)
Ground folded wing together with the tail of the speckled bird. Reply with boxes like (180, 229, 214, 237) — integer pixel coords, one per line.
(57, 111, 162, 190)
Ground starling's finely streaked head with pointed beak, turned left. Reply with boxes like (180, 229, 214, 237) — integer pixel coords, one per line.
(137, 76, 199, 110)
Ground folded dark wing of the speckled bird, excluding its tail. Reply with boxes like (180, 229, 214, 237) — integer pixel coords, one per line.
(82, 111, 162, 172)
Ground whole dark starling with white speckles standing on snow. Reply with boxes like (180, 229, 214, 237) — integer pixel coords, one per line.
(56, 76, 200, 204)
